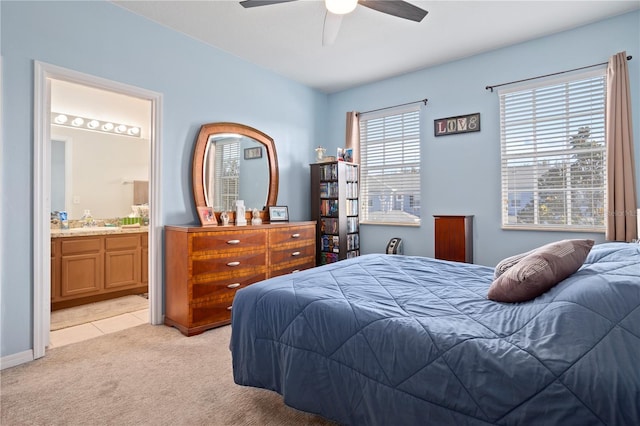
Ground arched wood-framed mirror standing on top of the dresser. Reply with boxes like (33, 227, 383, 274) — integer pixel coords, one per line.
(192, 123, 278, 225)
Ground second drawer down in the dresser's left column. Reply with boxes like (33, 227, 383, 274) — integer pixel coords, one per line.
(191, 248, 267, 279)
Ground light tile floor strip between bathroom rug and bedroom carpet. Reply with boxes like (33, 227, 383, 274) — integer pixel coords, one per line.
(49, 309, 149, 349)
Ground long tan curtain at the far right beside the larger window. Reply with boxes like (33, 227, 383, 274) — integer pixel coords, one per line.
(605, 52, 638, 241)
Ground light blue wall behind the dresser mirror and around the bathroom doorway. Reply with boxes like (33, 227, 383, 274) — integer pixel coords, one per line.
(0, 1, 327, 356)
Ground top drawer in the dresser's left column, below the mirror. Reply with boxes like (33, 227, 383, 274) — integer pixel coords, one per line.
(191, 230, 267, 255)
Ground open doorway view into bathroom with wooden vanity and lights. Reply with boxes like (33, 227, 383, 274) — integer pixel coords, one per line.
(49, 79, 151, 347)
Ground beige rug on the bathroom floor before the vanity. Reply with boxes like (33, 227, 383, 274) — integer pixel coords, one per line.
(51, 295, 149, 331)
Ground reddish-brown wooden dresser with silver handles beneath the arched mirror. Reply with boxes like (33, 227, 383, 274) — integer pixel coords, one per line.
(164, 221, 316, 336)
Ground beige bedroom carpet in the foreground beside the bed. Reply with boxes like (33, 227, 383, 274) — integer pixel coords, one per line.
(0, 324, 333, 426)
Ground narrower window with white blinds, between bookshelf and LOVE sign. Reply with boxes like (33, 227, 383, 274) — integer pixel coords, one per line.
(360, 105, 420, 225)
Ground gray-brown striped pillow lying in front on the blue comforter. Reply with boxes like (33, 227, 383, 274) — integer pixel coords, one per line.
(487, 240, 593, 302)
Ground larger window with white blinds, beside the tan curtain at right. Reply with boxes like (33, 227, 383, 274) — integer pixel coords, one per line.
(500, 71, 606, 231)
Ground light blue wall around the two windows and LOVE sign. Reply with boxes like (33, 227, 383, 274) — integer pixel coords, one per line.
(327, 12, 640, 265)
